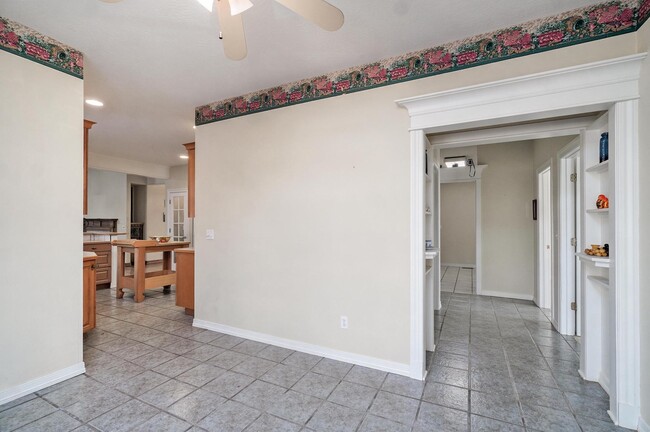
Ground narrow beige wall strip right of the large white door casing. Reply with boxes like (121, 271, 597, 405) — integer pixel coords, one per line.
(636, 21, 650, 432)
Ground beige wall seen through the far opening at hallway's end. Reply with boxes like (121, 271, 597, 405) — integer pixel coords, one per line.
(440, 182, 476, 266)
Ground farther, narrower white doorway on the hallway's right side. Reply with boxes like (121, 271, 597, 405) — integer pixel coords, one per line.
(533, 161, 553, 314)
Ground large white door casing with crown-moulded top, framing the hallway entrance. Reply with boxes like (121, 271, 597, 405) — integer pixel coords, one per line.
(396, 53, 646, 428)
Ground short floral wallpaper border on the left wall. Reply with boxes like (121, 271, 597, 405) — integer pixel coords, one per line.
(0, 17, 84, 79)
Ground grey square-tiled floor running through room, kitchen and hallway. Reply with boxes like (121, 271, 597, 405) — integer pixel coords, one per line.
(0, 290, 623, 432)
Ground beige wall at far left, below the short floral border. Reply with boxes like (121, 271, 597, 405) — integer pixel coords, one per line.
(0, 51, 83, 404)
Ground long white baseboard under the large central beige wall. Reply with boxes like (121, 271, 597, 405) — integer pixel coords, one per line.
(192, 318, 410, 377)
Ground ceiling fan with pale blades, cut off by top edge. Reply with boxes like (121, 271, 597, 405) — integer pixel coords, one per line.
(101, 0, 344, 60)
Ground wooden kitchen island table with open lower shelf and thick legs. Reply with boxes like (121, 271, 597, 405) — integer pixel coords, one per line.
(112, 240, 190, 303)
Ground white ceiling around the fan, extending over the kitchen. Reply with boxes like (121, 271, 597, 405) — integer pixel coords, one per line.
(0, 0, 602, 166)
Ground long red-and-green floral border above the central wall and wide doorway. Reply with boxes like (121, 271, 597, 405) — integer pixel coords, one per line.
(195, 0, 650, 126)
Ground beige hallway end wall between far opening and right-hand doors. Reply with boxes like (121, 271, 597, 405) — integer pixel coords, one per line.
(478, 141, 535, 299)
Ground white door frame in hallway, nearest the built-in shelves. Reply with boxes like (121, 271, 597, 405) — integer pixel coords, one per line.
(554, 140, 582, 336)
